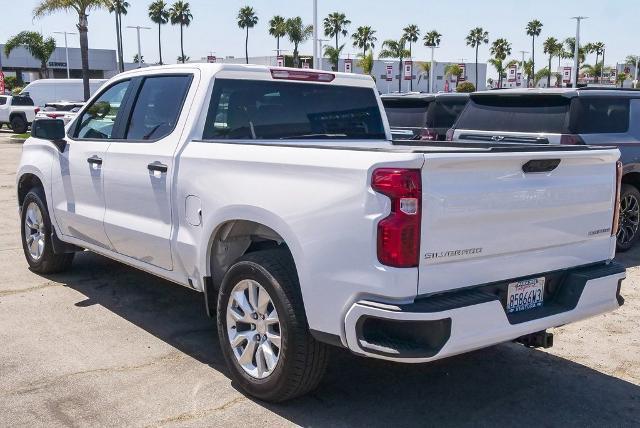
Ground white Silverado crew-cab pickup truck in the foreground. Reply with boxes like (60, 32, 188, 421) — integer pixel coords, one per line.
(17, 64, 625, 401)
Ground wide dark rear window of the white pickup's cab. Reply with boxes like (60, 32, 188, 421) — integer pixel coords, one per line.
(203, 79, 385, 140)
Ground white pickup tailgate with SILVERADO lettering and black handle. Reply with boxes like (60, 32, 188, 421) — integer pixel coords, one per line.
(418, 149, 620, 294)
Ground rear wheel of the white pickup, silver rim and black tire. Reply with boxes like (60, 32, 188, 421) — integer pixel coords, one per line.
(217, 250, 328, 402)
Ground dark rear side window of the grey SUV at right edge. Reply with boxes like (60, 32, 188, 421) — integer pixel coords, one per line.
(571, 97, 629, 134)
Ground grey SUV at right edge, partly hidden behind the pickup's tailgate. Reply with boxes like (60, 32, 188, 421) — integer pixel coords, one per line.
(448, 88, 640, 251)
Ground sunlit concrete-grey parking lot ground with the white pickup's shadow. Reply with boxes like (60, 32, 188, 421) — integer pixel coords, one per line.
(0, 129, 640, 427)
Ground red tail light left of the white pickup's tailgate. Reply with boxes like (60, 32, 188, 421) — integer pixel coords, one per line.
(371, 168, 422, 268)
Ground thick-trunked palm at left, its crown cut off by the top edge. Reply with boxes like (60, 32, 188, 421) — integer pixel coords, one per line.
(33, 0, 109, 101)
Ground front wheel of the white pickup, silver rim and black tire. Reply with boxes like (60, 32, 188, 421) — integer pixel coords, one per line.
(20, 187, 74, 274)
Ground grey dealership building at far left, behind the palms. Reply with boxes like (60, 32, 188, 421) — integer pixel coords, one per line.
(0, 44, 118, 84)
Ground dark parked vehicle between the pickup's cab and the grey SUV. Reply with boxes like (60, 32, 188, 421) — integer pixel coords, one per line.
(382, 93, 469, 141)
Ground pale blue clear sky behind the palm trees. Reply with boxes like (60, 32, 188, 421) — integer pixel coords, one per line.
(0, 0, 640, 76)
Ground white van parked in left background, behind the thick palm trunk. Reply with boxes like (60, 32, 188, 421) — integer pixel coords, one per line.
(20, 79, 106, 107)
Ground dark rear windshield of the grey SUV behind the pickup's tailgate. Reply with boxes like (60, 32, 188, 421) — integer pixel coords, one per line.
(456, 95, 571, 134)
